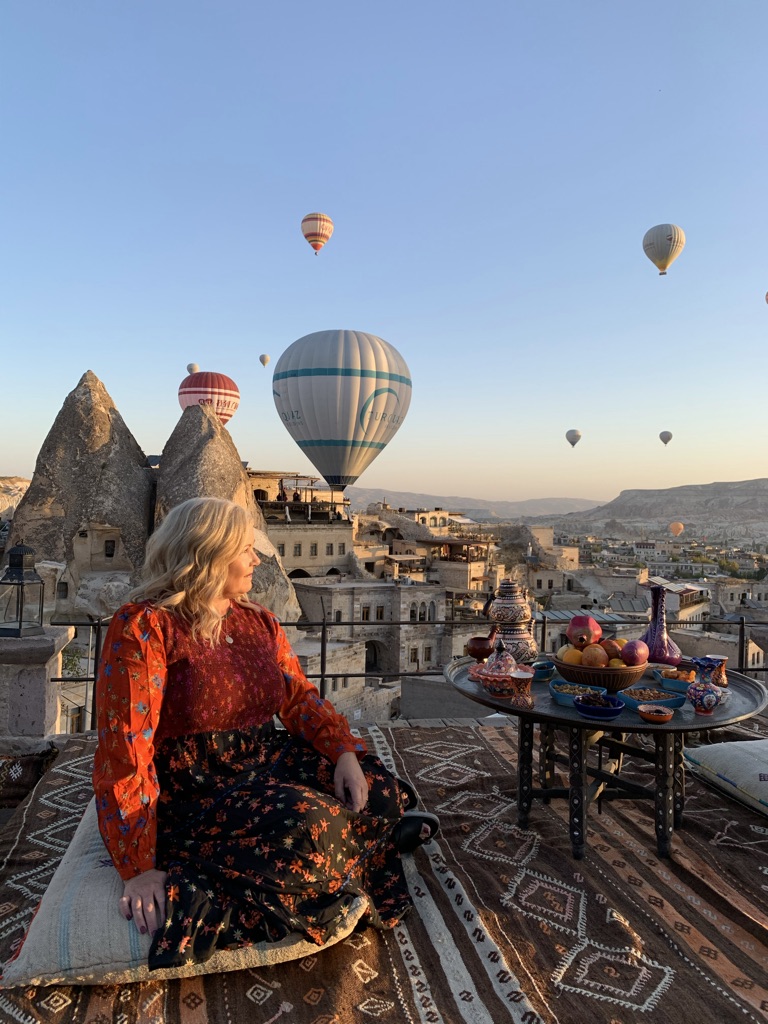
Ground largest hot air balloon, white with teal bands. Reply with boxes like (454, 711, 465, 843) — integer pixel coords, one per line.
(272, 331, 412, 490)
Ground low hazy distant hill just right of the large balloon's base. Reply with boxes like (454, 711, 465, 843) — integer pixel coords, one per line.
(344, 486, 600, 521)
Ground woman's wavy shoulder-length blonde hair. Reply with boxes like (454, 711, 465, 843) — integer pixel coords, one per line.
(129, 498, 253, 645)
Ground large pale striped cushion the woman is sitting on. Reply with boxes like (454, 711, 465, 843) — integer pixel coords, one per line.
(2, 800, 367, 988)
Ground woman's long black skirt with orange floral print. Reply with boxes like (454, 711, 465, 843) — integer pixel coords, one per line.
(148, 727, 411, 970)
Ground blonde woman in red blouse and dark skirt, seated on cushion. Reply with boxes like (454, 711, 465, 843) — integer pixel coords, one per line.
(93, 498, 439, 969)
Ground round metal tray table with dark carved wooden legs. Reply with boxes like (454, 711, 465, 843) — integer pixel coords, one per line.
(443, 657, 768, 860)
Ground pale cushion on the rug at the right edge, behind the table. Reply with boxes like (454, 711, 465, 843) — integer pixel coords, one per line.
(684, 739, 768, 814)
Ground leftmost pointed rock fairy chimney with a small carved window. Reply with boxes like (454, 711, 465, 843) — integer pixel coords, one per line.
(10, 370, 154, 615)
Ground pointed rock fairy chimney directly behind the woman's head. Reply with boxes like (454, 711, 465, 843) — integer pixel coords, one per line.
(155, 406, 301, 621)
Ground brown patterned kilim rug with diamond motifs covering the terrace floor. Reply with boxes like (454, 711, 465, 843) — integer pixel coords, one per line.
(0, 721, 768, 1024)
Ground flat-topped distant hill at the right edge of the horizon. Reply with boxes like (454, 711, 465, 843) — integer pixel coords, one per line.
(528, 479, 768, 544)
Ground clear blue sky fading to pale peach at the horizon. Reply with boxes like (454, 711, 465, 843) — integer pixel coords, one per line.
(0, 0, 768, 501)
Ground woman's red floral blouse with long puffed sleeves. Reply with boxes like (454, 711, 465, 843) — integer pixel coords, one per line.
(93, 603, 367, 880)
